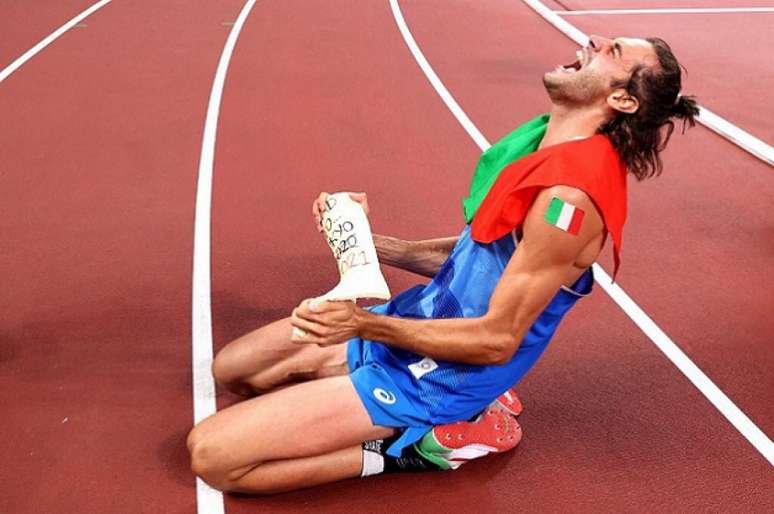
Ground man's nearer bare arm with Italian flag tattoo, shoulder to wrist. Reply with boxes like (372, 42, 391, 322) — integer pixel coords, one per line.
(356, 186, 604, 364)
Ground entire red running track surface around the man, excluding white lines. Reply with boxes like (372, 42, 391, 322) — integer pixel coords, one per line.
(0, 0, 774, 514)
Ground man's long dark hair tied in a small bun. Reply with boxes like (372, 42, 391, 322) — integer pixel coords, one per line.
(599, 38, 699, 180)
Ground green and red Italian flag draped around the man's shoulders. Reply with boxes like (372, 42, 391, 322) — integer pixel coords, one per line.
(462, 115, 627, 277)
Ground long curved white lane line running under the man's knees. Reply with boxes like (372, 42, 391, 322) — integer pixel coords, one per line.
(191, 0, 256, 514)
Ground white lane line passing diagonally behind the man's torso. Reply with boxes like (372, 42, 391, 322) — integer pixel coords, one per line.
(390, 0, 774, 466)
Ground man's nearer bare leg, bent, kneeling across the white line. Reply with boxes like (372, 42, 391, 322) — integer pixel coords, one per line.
(188, 376, 393, 493)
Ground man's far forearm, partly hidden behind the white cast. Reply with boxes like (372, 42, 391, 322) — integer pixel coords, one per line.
(373, 234, 459, 278)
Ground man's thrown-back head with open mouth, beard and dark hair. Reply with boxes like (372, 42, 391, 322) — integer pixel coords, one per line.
(543, 36, 699, 180)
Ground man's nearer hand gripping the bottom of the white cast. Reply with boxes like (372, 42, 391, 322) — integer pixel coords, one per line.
(290, 299, 363, 346)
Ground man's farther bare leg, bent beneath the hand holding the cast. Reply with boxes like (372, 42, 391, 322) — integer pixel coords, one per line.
(212, 318, 349, 396)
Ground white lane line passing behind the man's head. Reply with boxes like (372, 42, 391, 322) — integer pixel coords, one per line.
(521, 0, 774, 166)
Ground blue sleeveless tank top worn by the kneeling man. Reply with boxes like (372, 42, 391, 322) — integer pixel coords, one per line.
(368, 226, 593, 425)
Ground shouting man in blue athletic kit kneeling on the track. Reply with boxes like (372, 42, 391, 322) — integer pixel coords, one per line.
(188, 36, 698, 493)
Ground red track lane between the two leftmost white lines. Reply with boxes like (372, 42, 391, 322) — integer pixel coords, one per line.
(0, 0, 246, 513)
